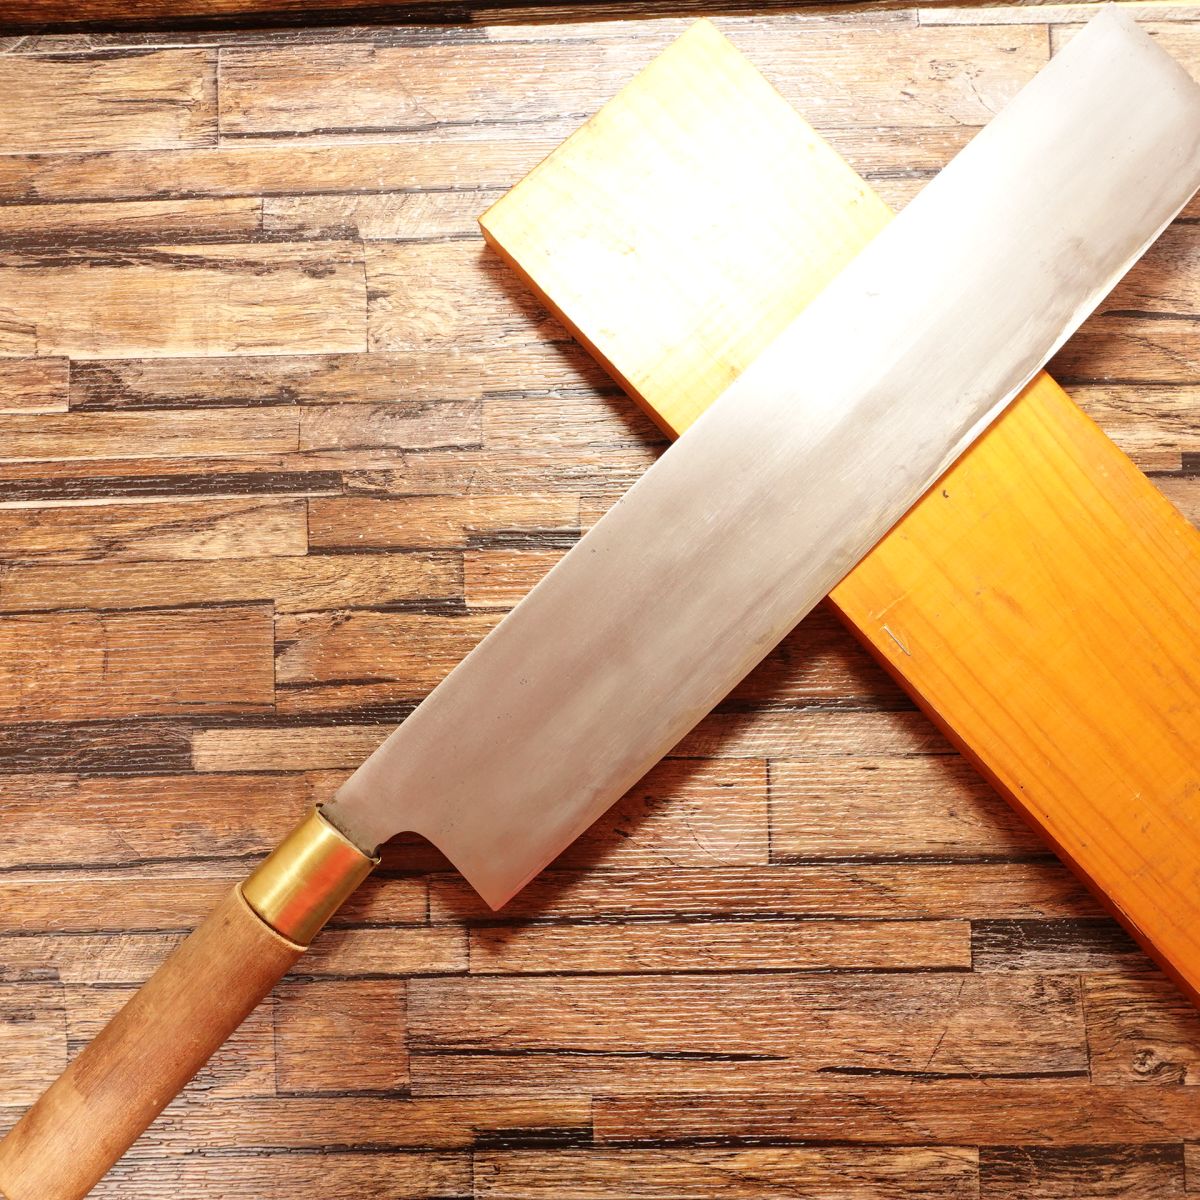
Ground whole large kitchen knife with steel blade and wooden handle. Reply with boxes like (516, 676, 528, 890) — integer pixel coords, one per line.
(0, 13, 1200, 1200)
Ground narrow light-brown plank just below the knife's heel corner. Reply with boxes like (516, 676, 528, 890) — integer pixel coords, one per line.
(470, 920, 971, 974)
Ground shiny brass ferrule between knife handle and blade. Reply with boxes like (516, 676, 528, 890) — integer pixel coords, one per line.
(241, 809, 379, 946)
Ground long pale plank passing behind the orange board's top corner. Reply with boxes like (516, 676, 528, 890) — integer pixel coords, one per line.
(221, 19, 1048, 137)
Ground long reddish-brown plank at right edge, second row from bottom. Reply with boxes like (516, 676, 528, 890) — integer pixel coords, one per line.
(593, 1079, 1200, 1146)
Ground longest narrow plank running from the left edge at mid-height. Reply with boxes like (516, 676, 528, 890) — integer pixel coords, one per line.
(0, 549, 462, 613)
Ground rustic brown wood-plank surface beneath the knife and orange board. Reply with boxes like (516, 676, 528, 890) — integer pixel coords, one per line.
(0, 7, 1200, 1200)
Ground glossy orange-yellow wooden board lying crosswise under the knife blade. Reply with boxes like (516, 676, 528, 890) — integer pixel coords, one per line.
(481, 22, 1200, 1000)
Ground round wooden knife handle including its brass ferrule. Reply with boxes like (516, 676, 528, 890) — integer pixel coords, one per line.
(0, 811, 377, 1200)
